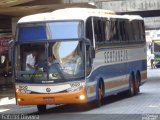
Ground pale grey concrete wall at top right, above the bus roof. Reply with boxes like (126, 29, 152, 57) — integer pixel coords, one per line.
(96, 0, 160, 12)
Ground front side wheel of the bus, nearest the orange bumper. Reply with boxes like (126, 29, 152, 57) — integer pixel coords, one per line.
(96, 82, 103, 107)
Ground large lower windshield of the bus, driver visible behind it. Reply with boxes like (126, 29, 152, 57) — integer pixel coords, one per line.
(15, 41, 84, 83)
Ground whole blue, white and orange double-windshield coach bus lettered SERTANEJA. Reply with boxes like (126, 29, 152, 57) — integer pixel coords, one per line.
(13, 8, 147, 111)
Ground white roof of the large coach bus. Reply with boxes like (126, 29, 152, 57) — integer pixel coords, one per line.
(18, 8, 142, 23)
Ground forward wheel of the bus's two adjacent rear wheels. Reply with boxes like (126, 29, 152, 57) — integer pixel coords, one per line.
(128, 74, 135, 97)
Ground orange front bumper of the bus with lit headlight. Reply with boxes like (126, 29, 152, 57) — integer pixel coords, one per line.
(16, 88, 87, 105)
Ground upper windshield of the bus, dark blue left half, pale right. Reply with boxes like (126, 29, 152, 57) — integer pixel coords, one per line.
(17, 21, 83, 42)
